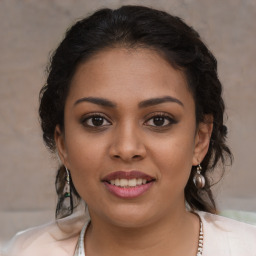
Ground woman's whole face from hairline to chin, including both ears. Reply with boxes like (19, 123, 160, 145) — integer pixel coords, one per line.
(55, 48, 211, 226)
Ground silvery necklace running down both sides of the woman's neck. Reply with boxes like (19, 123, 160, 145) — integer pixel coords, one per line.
(74, 215, 204, 256)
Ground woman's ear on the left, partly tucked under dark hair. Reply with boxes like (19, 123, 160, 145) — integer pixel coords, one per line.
(54, 125, 67, 166)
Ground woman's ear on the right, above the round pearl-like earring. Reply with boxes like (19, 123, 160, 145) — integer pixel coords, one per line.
(192, 115, 213, 166)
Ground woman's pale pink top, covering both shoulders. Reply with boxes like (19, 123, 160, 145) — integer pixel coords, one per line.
(1, 211, 256, 256)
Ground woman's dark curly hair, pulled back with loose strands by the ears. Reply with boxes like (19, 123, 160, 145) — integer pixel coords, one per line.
(39, 5, 232, 217)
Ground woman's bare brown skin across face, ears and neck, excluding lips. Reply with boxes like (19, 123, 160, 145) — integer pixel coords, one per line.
(55, 48, 212, 256)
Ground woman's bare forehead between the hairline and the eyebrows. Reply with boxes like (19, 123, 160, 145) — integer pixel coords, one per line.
(68, 48, 191, 107)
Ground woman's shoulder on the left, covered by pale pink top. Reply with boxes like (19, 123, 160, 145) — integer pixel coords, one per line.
(1, 212, 88, 256)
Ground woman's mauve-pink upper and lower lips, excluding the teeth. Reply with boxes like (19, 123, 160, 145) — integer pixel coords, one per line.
(102, 170, 156, 199)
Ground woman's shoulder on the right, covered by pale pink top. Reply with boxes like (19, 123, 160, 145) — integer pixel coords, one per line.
(198, 212, 256, 256)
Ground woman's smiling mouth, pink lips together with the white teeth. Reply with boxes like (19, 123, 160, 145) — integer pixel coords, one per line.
(102, 171, 156, 199)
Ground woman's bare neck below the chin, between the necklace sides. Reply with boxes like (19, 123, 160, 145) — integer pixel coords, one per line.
(85, 208, 199, 256)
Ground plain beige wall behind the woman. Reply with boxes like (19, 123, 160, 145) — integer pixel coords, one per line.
(0, 0, 256, 244)
